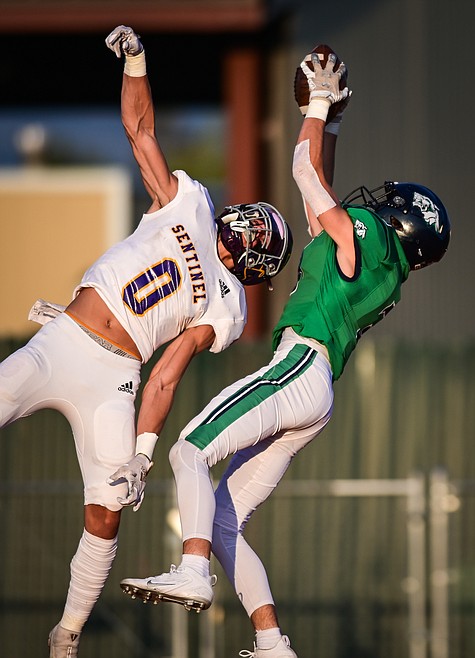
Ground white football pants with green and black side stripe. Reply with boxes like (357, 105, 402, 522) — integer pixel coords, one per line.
(170, 330, 333, 616)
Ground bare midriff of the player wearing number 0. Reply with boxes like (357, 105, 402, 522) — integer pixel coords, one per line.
(66, 288, 141, 359)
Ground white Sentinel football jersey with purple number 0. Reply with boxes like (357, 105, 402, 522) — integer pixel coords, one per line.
(74, 171, 246, 363)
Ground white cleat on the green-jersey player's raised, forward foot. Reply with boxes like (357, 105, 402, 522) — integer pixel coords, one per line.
(120, 564, 217, 612)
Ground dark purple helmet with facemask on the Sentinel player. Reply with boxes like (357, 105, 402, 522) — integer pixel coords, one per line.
(216, 202, 292, 285)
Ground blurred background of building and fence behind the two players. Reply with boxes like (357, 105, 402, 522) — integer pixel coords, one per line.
(0, 0, 475, 658)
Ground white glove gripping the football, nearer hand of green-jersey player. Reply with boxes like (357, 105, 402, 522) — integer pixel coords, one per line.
(300, 53, 350, 121)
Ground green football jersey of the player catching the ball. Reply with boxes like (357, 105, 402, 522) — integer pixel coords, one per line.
(273, 206, 409, 380)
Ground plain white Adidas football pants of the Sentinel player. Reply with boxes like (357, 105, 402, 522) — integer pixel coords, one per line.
(0, 313, 141, 511)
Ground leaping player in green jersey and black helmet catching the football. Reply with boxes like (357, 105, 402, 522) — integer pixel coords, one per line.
(121, 48, 450, 658)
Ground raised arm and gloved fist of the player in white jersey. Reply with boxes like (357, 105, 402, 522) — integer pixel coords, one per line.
(106, 25, 178, 212)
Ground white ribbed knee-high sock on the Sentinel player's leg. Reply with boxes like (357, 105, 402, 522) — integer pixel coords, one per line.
(60, 530, 117, 633)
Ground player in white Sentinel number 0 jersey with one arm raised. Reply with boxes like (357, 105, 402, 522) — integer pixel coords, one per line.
(0, 25, 292, 658)
